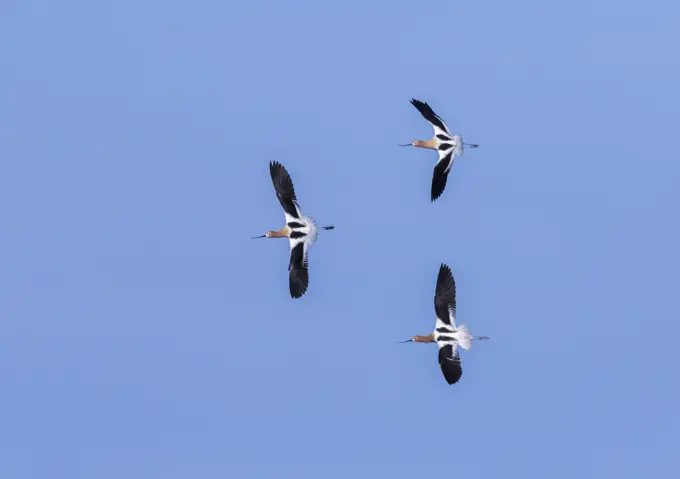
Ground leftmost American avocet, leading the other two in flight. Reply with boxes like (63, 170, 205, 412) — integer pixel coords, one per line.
(253, 161, 335, 298)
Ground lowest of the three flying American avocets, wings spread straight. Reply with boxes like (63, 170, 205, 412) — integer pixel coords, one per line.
(401, 264, 489, 384)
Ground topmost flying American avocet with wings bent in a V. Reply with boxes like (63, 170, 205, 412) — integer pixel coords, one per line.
(399, 98, 479, 201)
